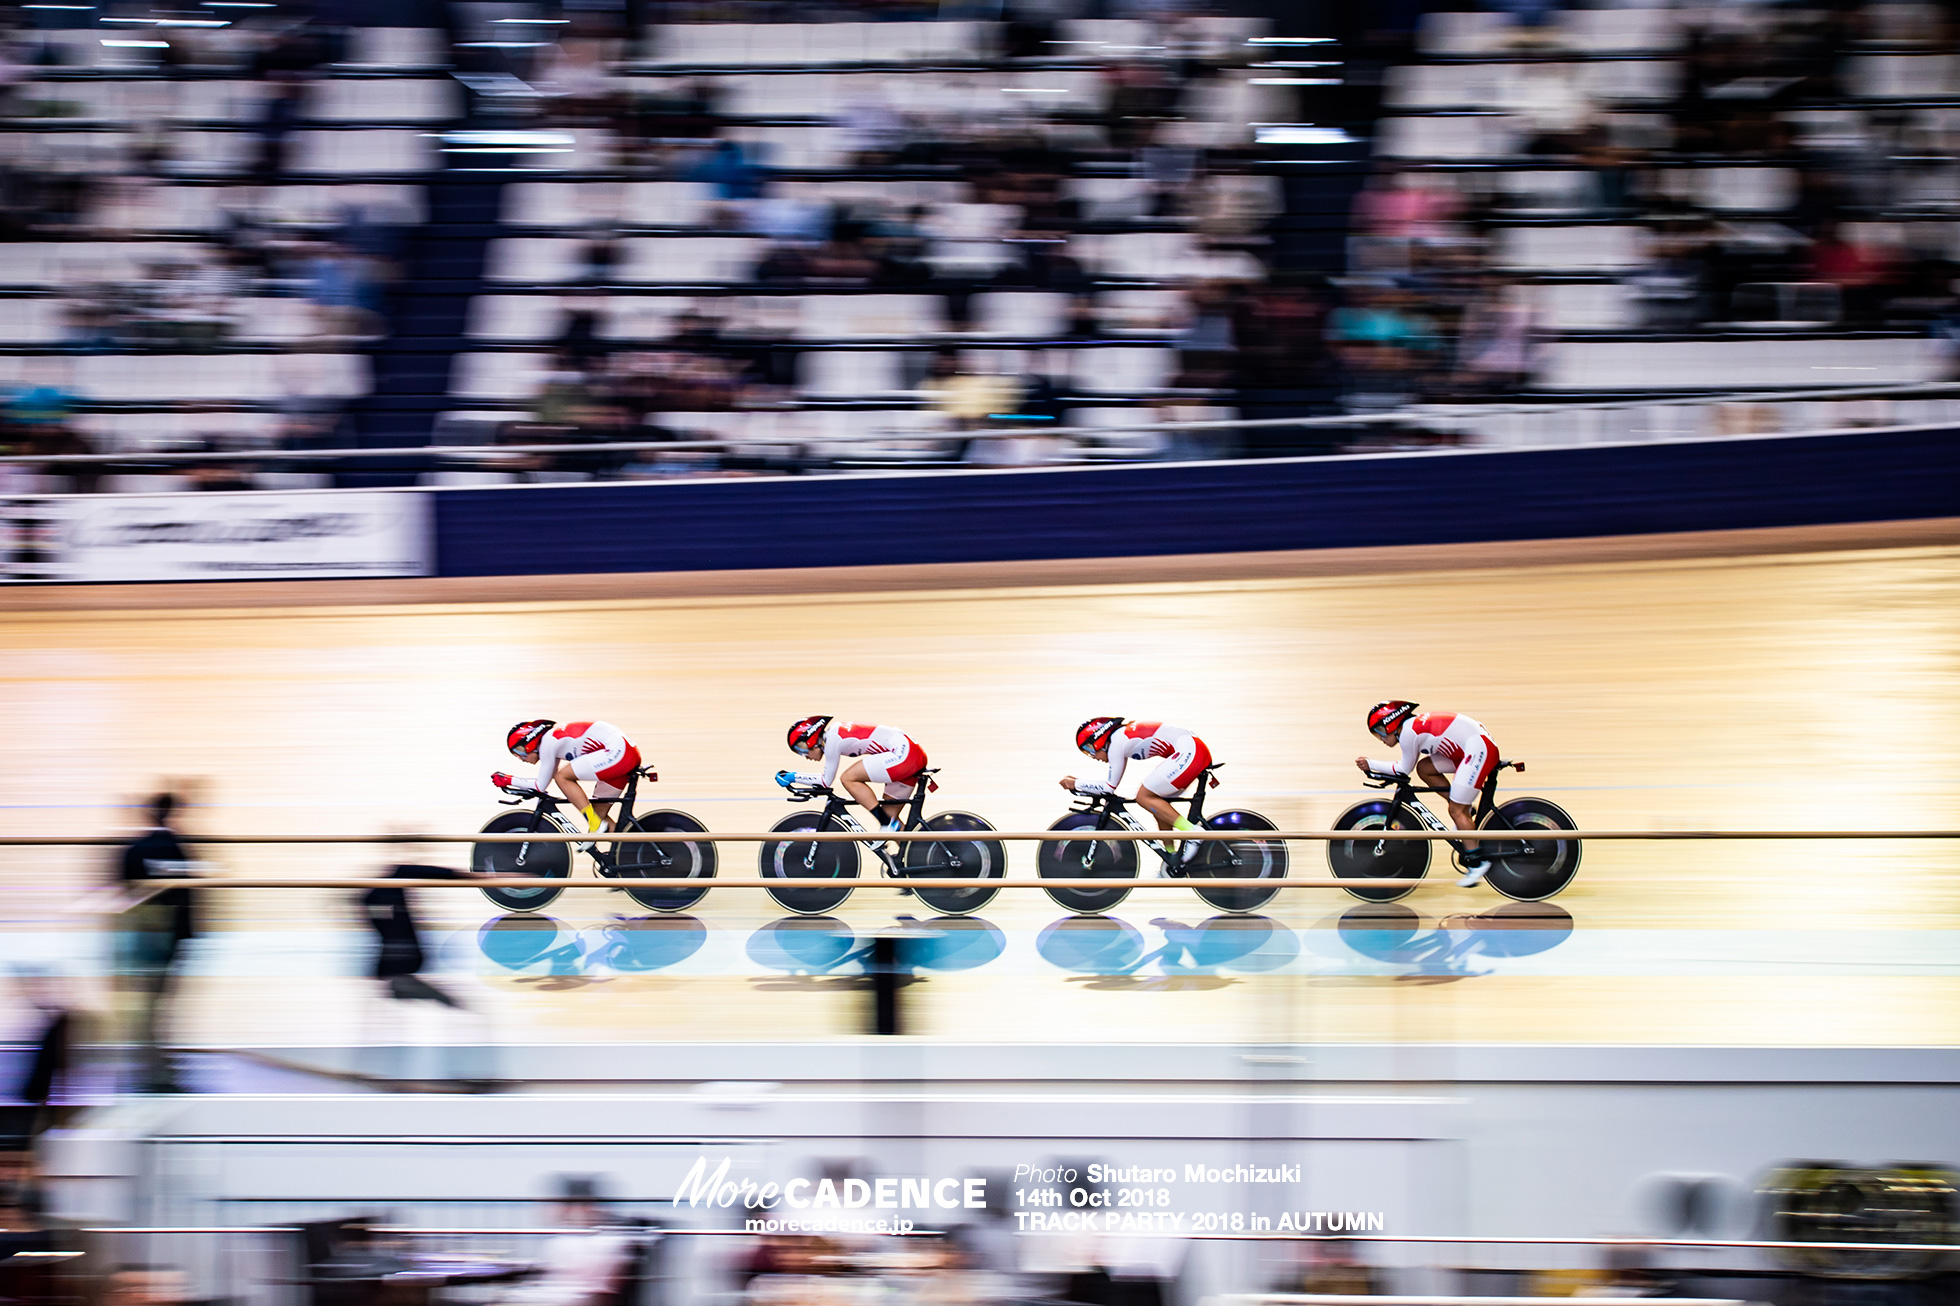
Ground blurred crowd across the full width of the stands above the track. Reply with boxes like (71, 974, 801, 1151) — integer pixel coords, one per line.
(0, 0, 1960, 490)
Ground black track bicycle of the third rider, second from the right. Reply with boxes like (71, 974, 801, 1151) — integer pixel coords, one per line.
(1035, 763, 1286, 912)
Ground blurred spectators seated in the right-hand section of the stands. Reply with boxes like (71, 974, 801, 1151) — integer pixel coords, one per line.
(1327, 4, 1960, 406)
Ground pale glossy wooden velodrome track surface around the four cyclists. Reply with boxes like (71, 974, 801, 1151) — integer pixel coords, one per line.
(0, 522, 1960, 1045)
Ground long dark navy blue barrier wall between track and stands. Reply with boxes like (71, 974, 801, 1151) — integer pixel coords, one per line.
(435, 429, 1960, 577)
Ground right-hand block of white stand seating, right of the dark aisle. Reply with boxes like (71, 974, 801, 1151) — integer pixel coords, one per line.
(1333, 4, 1960, 427)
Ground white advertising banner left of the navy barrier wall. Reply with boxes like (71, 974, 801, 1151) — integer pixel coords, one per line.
(4, 490, 433, 582)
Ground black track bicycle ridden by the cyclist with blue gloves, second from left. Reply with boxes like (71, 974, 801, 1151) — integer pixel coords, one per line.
(760, 767, 1007, 916)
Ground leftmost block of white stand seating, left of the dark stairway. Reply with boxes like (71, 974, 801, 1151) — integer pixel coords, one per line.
(0, 6, 463, 490)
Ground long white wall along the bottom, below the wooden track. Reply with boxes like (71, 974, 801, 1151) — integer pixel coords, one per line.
(34, 1039, 1960, 1300)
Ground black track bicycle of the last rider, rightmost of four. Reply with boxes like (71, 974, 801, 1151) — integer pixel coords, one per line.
(1327, 761, 1582, 902)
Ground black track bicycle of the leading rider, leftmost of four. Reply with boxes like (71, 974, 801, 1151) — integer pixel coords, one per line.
(470, 767, 715, 912)
